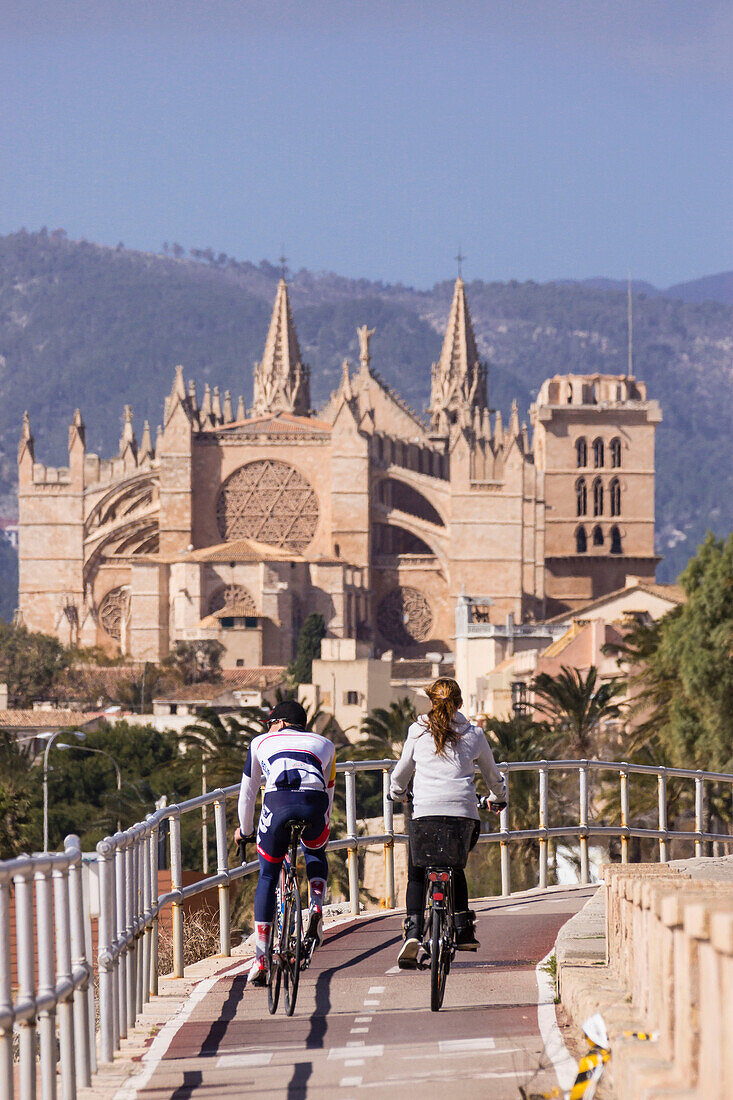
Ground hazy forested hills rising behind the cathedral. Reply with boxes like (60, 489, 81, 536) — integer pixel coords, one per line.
(0, 231, 733, 620)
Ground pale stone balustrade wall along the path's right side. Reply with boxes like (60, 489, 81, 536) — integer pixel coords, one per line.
(558, 859, 733, 1100)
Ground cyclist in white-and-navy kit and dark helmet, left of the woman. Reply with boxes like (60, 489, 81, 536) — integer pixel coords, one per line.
(234, 700, 336, 986)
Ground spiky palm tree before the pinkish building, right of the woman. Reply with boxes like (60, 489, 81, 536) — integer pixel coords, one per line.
(532, 664, 625, 759)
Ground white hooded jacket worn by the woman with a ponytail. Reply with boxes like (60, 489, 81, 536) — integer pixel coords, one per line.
(390, 712, 506, 820)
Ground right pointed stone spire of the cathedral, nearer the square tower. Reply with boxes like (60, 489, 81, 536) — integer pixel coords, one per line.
(428, 275, 488, 431)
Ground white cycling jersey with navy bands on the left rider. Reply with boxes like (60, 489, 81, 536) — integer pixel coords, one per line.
(238, 729, 336, 836)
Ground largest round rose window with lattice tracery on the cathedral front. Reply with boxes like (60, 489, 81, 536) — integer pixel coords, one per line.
(217, 459, 318, 553)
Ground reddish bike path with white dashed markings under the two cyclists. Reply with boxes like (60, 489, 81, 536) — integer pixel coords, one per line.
(138, 890, 592, 1100)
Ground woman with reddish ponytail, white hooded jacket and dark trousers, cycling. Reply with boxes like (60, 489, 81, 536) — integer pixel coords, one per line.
(390, 677, 506, 970)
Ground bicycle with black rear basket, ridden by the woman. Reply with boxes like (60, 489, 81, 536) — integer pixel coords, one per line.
(411, 798, 505, 1012)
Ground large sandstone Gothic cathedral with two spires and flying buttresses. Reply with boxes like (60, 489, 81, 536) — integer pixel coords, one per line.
(18, 277, 660, 668)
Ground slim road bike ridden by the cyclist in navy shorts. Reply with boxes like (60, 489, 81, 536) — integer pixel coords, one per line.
(267, 818, 316, 1016)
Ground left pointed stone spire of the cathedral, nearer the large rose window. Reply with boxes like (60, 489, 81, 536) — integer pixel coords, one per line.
(252, 278, 310, 416)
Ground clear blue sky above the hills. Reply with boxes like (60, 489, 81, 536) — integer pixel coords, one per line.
(0, 0, 733, 287)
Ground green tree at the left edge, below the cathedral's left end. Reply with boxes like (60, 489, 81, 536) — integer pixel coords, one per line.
(0, 623, 69, 707)
